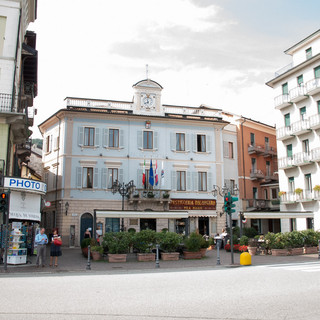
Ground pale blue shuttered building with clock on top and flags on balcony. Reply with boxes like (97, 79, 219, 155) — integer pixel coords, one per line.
(39, 79, 239, 245)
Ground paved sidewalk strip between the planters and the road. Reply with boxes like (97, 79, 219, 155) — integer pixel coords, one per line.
(0, 248, 320, 275)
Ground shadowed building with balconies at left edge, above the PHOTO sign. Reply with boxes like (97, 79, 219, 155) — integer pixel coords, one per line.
(0, 0, 38, 176)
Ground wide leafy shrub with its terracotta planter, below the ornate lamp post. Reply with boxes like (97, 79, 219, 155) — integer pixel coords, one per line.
(102, 232, 132, 262)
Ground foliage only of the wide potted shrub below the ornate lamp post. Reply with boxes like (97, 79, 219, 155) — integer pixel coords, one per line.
(102, 232, 132, 254)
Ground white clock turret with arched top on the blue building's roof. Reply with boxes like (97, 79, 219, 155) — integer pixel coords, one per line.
(132, 79, 163, 115)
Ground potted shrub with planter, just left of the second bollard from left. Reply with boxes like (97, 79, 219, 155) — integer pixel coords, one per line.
(133, 229, 157, 261)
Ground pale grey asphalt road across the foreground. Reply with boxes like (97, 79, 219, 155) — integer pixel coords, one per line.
(0, 262, 320, 320)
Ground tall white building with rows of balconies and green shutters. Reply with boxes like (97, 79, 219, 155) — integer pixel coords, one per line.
(267, 30, 320, 231)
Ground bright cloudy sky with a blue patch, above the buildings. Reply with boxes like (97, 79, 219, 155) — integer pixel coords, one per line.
(28, 0, 320, 138)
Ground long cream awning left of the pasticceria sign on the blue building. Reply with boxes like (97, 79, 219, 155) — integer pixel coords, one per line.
(96, 210, 188, 219)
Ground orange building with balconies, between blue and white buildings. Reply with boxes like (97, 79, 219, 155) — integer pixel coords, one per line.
(223, 112, 280, 233)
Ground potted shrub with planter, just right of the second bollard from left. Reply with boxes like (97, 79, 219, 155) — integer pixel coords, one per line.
(159, 232, 182, 261)
